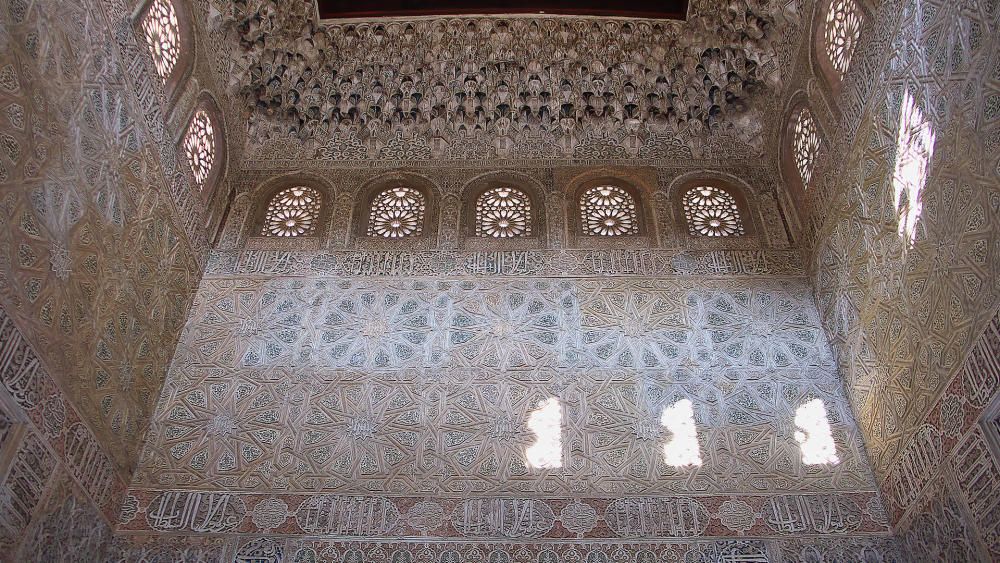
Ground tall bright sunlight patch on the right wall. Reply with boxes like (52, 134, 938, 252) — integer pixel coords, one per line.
(892, 90, 934, 246)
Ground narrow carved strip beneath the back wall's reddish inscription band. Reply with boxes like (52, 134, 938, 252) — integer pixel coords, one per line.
(109, 535, 904, 563)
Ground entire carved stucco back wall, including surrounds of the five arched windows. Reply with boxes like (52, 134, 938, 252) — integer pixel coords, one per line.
(103, 158, 897, 561)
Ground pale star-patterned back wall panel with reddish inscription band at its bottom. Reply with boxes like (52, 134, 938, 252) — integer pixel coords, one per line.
(127, 275, 887, 560)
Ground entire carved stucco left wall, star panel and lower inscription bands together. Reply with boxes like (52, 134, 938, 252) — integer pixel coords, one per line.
(0, 1, 218, 561)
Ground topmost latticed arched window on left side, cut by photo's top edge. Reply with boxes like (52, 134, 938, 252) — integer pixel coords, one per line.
(136, 0, 194, 106)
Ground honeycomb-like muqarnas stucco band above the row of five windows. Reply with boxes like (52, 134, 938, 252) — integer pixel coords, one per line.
(221, 0, 798, 161)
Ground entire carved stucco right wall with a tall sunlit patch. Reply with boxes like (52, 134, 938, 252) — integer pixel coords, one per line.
(811, 0, 1000, 561)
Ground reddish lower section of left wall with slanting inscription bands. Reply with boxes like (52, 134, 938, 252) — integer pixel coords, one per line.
(0, 309, 125, 561)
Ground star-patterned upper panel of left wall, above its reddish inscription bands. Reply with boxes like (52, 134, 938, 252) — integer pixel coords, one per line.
(0, 2, 200, 477)
